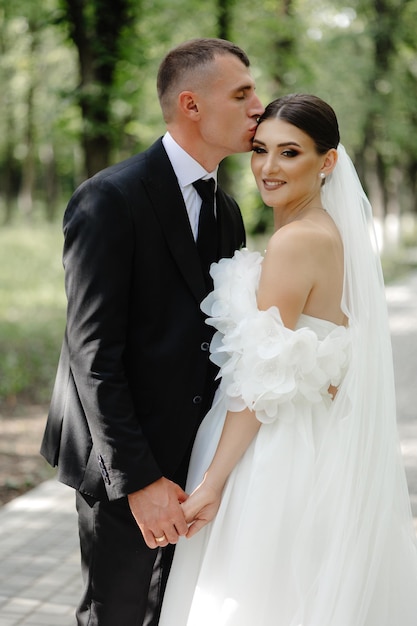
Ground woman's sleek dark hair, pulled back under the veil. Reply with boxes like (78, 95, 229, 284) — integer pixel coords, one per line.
(259, 93, 340, 154)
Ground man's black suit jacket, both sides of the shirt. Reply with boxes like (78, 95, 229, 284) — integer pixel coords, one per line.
(41, 140, 245, 500)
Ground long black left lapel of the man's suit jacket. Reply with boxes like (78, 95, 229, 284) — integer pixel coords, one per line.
(143, 140, 206, 303)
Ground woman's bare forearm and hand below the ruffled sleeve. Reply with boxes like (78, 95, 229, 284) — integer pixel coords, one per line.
(182, 409, 261, 538)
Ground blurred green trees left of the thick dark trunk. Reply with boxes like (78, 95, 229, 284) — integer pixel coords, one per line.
(0, 0, 76, 222)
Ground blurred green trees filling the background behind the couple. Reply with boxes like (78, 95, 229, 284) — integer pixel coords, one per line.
(0, 0, 417, 231)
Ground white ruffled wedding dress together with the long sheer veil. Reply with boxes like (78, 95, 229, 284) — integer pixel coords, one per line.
(159, 144, 417, 626)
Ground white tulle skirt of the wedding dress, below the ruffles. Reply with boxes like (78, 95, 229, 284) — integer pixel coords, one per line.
(160, 393, 417, 626)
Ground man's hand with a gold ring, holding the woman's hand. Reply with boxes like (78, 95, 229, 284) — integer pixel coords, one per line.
(128, 478, 188, 548)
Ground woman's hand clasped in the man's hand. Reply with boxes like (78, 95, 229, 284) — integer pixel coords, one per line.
(181, 480, 221, 539)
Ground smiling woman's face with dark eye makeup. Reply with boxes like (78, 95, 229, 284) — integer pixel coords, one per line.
(251, 118, 326, 210)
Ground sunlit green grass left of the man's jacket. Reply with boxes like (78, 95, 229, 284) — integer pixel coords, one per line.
(0, 224, 65, 406)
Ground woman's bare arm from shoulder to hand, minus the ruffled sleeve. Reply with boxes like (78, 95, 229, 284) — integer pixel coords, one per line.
(182, 222, 338, 537)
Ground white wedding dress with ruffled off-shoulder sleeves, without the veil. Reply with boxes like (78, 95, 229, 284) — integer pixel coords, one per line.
(159, 250, 417, 626)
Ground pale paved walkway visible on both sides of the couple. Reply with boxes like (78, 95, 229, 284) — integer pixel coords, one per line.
(0, 272, 417, 626)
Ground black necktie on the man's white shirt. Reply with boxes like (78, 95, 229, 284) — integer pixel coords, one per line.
(193, 178, 217, 285)
